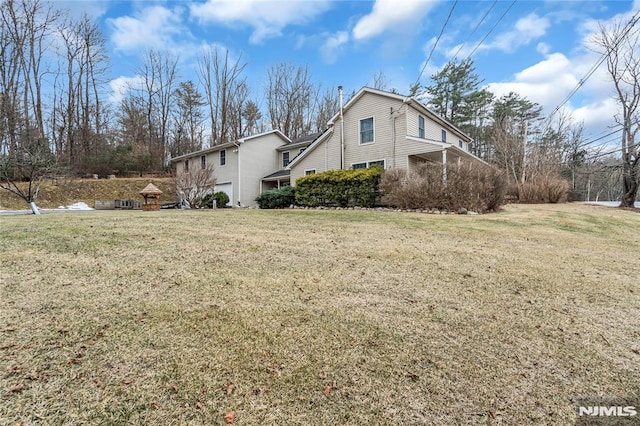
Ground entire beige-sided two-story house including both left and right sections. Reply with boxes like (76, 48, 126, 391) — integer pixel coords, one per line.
(171, 87, 482, 207)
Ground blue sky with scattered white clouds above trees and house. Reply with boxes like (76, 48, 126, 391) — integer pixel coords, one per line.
(60, 0, 640, 143)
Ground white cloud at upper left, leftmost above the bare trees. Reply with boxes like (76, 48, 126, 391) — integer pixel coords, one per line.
(108, 6, 189, 53)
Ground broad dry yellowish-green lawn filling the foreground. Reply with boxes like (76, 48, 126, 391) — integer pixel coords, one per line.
(0, 205, 640, 425)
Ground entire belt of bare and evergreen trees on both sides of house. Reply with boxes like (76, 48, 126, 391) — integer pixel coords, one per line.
(0, 0, 640, 205)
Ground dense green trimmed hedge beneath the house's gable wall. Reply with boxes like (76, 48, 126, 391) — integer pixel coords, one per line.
(296, 166, 383, 207)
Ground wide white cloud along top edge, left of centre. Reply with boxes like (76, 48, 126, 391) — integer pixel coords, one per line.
(191, 0, 330, 44)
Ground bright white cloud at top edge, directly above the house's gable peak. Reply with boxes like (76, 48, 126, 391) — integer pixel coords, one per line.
(353, 0, 438, 40)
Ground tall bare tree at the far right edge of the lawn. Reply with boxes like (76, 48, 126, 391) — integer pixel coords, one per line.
(595, 14, 640, 207)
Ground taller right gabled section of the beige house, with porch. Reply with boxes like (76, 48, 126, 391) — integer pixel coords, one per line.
(288, 87, 482, 185)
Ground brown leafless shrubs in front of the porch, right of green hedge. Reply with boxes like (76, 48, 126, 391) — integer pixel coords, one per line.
(380, 163, 506, 212)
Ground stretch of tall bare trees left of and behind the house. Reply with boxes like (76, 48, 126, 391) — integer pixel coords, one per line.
(0, 0, 338, 175)
